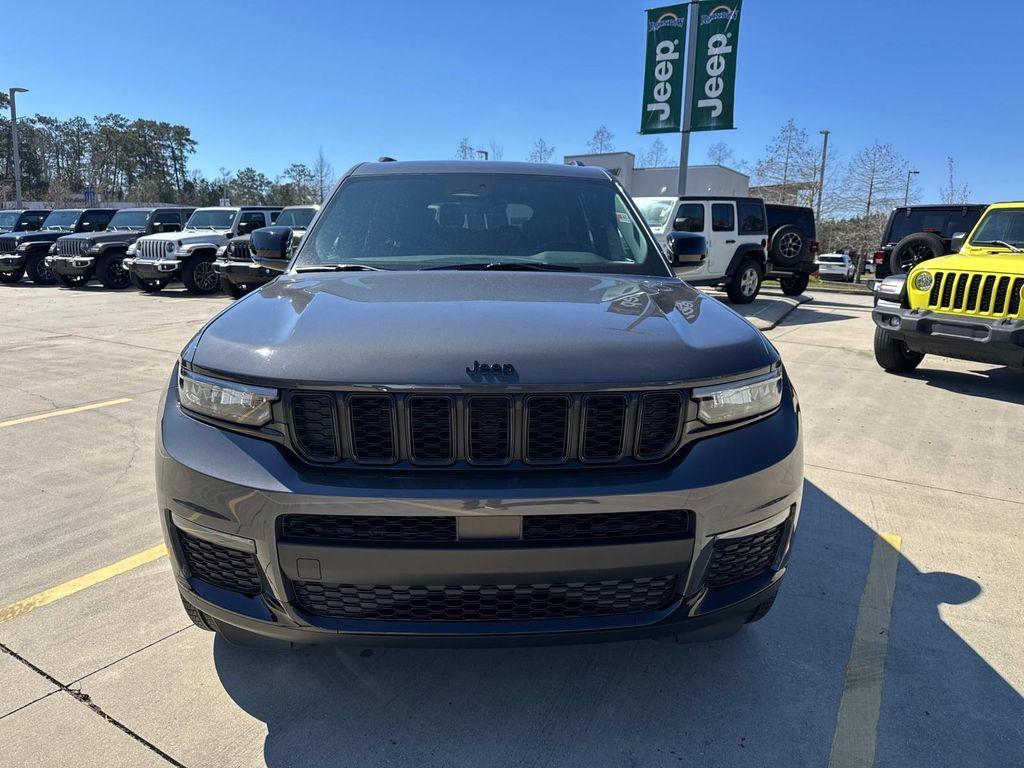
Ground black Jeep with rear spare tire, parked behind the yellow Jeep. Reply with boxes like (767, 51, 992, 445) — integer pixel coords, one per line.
(874, 203, 988, 280)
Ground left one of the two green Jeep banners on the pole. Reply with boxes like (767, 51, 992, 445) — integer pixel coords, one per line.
(640, 4, 686, 133)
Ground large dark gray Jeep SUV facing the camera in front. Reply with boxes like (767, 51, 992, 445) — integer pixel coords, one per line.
(157, 162, 803, 645)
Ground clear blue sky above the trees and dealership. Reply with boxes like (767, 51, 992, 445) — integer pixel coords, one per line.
(8, 0, 1024, 202)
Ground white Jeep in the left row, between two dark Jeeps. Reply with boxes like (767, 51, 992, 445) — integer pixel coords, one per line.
(123, 206, 281, 294)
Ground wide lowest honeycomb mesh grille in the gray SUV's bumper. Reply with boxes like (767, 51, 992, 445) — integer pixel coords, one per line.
(293, 575, 678, 622)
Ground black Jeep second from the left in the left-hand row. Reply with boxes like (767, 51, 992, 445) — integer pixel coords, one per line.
(0, 208, 117, 286)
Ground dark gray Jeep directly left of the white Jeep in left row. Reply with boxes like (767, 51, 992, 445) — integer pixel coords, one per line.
(46, 208, 196, 289)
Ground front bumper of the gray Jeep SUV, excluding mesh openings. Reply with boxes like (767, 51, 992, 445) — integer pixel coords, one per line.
(157, 372, 803, 645)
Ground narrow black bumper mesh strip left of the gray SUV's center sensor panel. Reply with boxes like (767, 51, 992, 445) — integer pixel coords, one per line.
(281, 515, 456, 543)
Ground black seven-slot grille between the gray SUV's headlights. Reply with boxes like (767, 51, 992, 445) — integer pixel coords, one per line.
(290, 391, 685, 466)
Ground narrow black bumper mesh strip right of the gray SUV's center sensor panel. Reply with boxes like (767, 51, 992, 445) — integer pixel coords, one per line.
(522, 510, 690, 544)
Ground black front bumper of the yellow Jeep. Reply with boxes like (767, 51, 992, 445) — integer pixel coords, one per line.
(871, 298, 1024, 368)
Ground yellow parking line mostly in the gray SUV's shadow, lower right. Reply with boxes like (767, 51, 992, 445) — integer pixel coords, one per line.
(828, 534, 903, 768)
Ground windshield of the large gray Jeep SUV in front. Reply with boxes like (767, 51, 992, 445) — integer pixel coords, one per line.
(295, 173, 668, 276)
